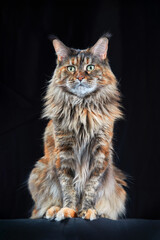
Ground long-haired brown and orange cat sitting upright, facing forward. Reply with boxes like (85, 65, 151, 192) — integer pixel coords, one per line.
(28, 34, 127, 221)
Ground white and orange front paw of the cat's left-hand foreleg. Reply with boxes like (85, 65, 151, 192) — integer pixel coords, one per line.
(55, 207, 77, 221)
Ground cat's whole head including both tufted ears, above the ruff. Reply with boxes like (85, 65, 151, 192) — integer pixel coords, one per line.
(52, 34, 114, 98)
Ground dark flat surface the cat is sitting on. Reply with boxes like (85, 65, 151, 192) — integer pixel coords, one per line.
(0, 218, 160, 240)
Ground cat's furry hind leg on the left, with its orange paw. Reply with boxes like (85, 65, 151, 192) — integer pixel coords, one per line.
(28, 157, 62, 219)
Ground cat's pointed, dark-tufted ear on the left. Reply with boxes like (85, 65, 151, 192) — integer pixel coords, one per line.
(49, 35, 70, 61)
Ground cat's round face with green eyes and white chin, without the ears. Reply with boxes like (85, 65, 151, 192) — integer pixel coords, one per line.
(58, 52, 103, 97)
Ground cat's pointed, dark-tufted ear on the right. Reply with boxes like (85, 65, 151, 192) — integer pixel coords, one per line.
(90, 33, 111, 60)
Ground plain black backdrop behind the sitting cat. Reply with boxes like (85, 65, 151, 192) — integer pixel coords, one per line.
(0, 0, 160, 219)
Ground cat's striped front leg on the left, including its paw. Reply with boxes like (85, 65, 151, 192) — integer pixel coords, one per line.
(56, 144, 77, 221)
